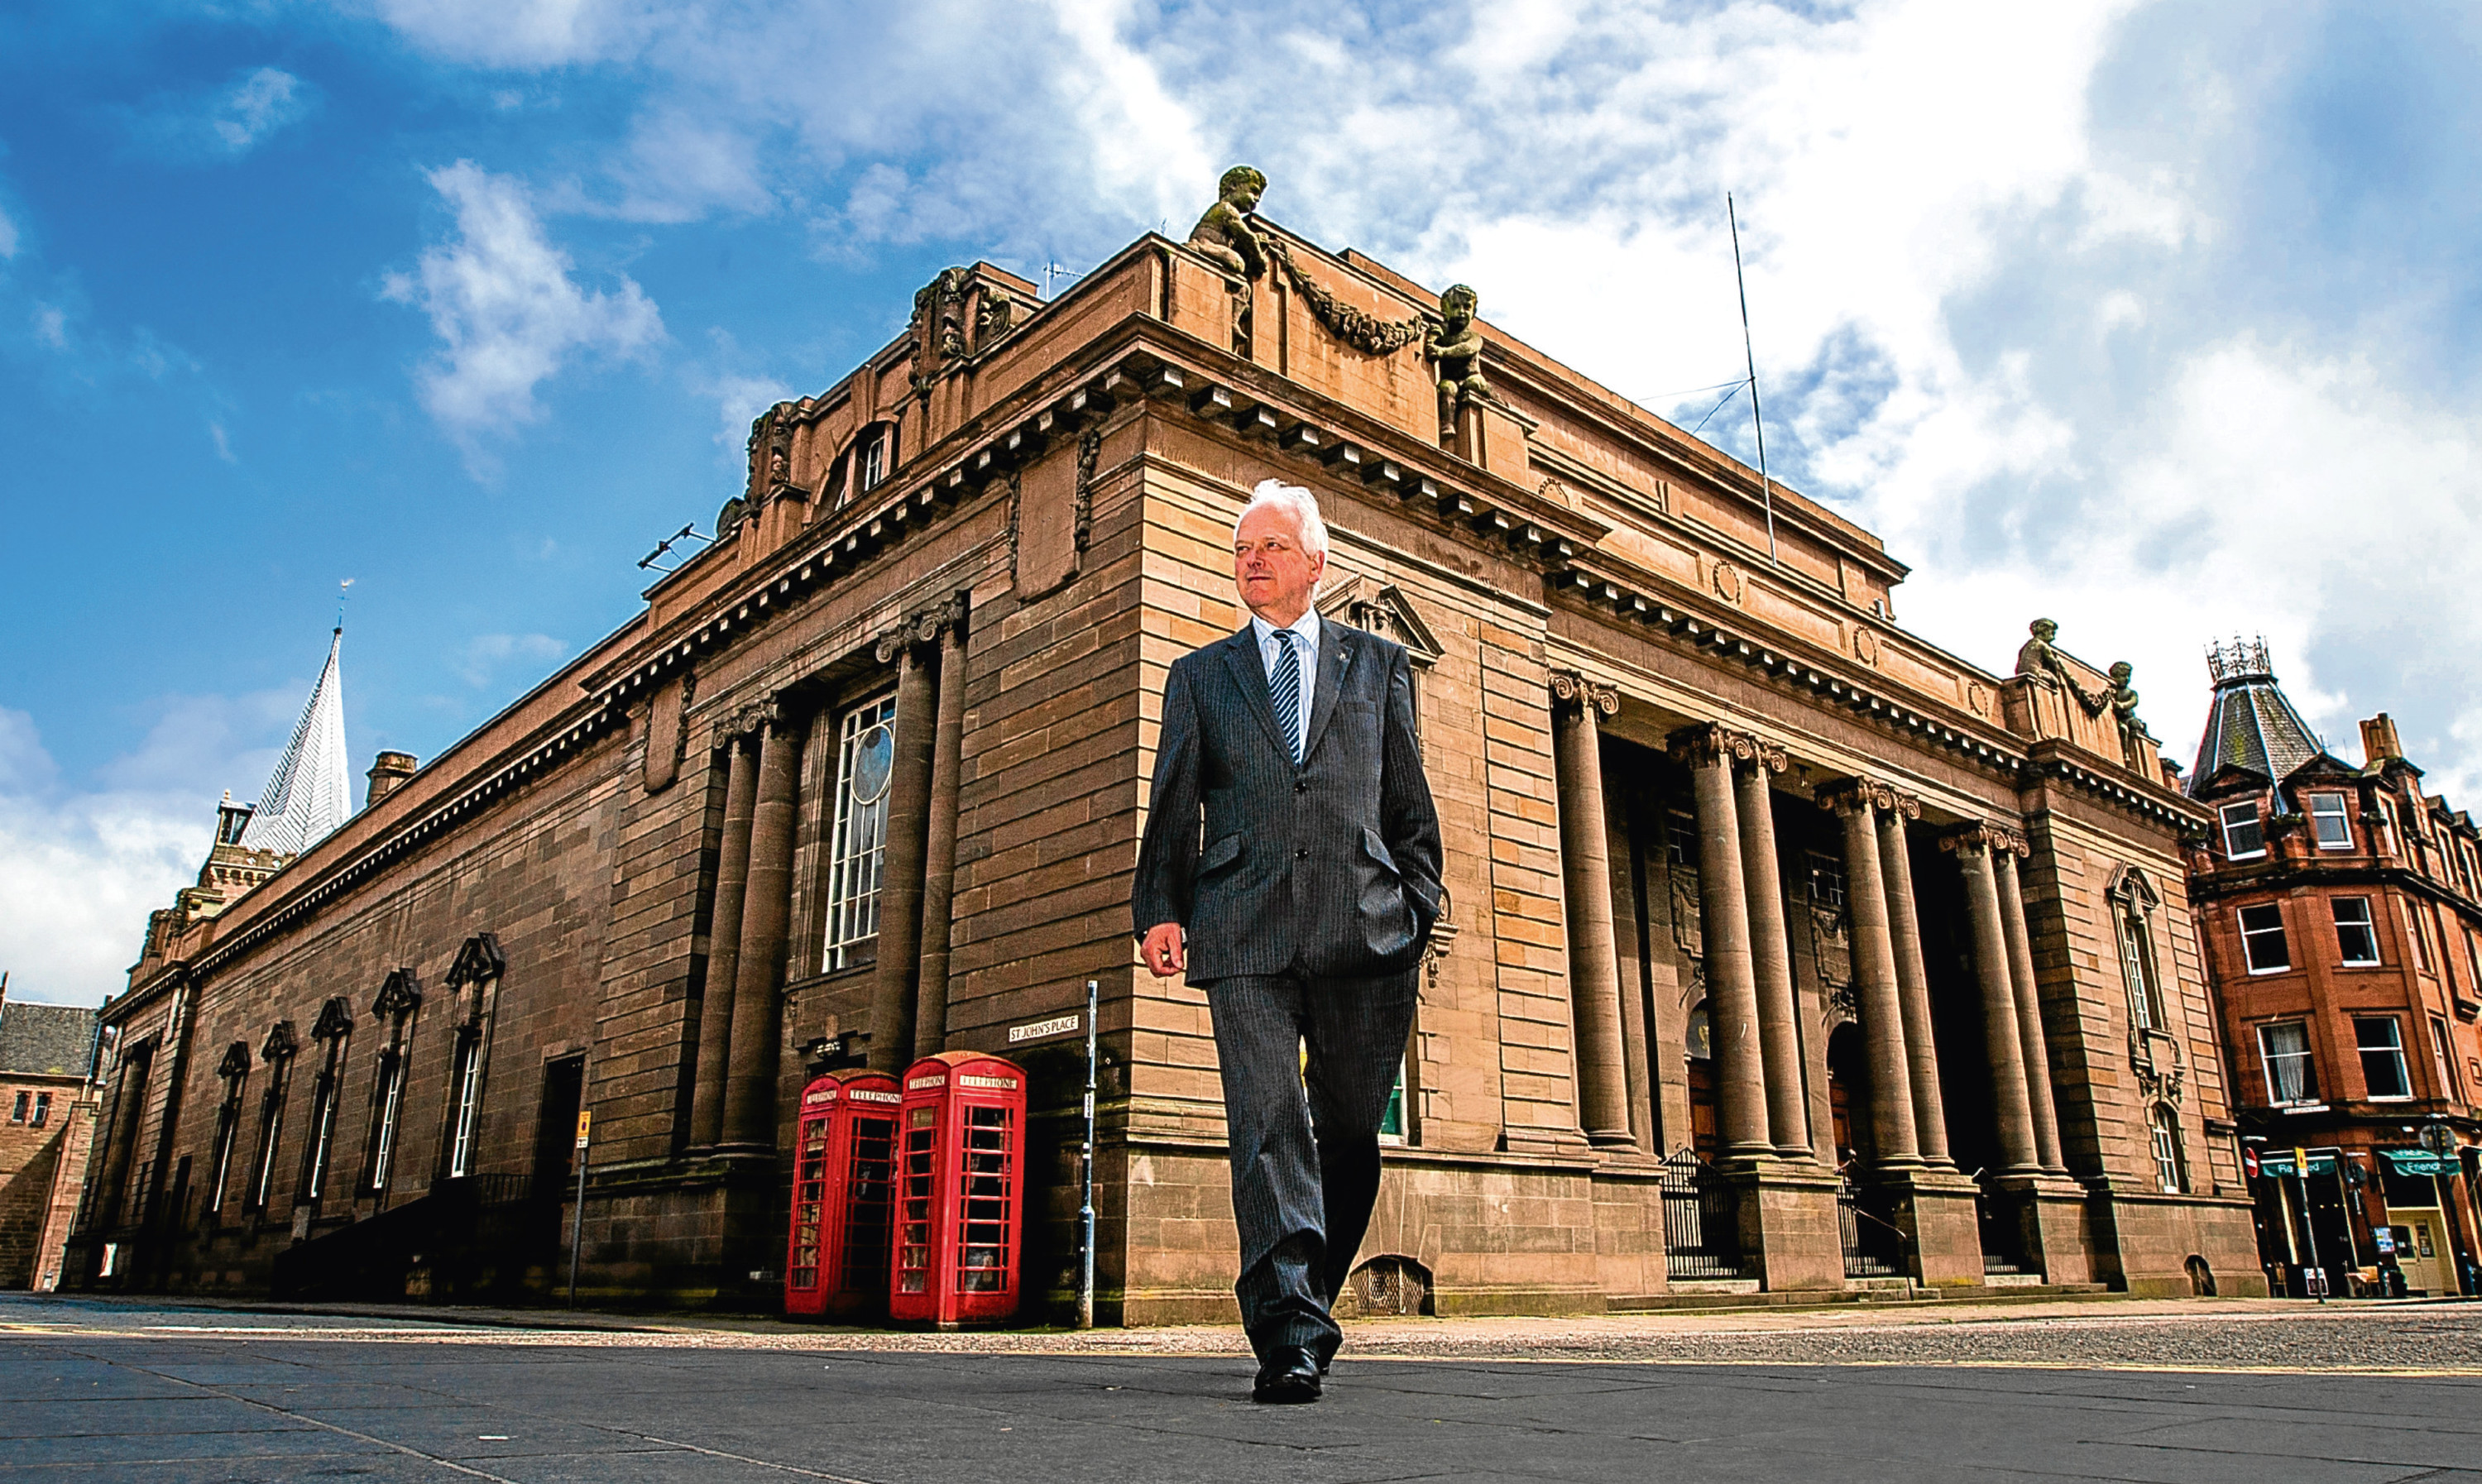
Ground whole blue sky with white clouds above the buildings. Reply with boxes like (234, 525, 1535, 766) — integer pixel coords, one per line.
(0, 0, 2482, 1000)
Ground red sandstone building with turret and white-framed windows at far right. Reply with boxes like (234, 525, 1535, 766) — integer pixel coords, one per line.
(2189, 640, 2482, 1293)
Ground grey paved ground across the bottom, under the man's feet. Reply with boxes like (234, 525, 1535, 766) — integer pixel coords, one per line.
(0, 1293, 2482, 1484)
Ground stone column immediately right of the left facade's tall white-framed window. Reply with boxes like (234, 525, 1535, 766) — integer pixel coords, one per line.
(871, 618, 938, 1075)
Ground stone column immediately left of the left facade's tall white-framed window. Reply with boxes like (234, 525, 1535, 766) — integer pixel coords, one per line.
(722, 705, 802, 1149)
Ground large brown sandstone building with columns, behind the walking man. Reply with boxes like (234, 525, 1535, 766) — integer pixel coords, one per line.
(63, 184, 2259, 1323)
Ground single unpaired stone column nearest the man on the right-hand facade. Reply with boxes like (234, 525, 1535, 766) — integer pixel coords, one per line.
(1551, 670, 1636, 1147)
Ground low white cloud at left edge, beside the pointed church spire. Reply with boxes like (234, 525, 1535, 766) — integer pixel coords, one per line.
(0, 700, 308, 1005)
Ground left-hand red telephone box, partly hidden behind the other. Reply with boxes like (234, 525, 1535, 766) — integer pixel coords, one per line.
(784, 1072, 903, 1315)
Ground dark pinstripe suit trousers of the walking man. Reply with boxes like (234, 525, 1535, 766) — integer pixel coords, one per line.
(1201, 970, 1417, 1362)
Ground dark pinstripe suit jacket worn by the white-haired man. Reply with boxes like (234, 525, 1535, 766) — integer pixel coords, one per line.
(1129, 618, 1440, 983)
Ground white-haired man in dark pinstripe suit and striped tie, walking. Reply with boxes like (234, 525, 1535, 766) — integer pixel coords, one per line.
(1132, 479, 1440, 1402)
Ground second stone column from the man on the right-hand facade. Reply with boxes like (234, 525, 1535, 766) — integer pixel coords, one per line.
(1670, 725, 1775, 1159)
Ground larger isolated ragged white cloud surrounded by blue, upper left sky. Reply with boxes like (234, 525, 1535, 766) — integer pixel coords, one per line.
(382, 161, 663, 467)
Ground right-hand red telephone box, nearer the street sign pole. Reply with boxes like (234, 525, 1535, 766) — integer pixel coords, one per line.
(889, 1052, 1025, 1328)
